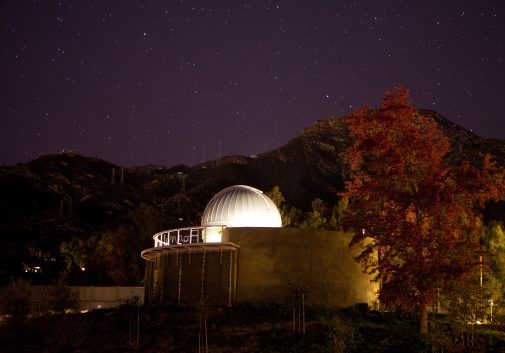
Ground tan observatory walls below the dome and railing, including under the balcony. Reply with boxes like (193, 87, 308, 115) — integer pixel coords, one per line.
(145, 228, 378, 307)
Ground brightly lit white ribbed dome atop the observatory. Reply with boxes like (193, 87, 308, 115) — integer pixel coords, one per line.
(202, 185, 282, 227)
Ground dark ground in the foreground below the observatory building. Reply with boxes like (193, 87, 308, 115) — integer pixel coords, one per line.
(0, 304, 505, 353)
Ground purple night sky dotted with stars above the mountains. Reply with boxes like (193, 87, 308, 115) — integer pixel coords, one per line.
(0, 0, 505, 166)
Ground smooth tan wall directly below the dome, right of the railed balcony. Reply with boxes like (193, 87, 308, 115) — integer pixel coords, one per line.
(223, 228, 378, 307)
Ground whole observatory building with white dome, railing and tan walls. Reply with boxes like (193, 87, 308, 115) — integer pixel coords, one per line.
(142, 185, 378, 307)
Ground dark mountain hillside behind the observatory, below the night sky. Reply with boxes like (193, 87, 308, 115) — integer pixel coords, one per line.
(0, 110, 505, 282)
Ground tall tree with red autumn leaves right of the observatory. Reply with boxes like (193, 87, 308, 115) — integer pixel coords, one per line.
(343, 86, 504, 333)
